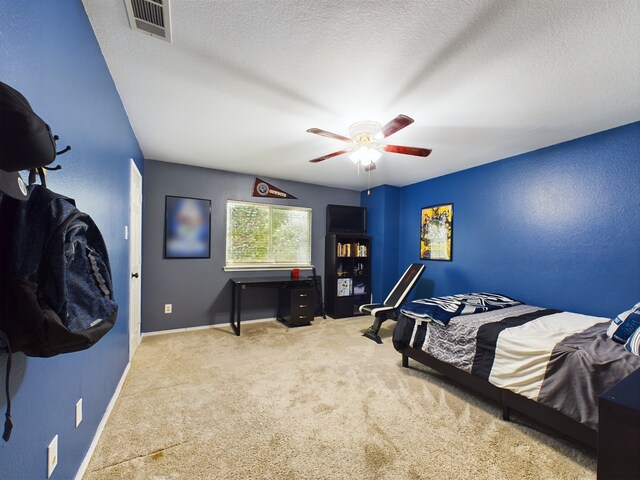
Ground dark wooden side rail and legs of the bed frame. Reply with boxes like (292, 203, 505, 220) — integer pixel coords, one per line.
(400, 347, 598, 449)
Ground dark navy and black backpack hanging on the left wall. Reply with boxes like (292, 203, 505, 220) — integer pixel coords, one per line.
(0, 185, 118, 357)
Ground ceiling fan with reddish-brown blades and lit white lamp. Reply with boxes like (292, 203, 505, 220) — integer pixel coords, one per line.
(307, 114, 431, 171)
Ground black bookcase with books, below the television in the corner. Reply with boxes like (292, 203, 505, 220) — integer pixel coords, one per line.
(324, 234, 371, 318)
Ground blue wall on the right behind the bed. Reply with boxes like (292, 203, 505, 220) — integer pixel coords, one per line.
(363, 122, 640, 316)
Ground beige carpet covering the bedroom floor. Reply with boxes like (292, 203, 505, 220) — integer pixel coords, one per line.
(84, 317, 595, 480)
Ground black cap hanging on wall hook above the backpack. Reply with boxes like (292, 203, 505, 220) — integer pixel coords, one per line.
(0, 82, 56, 200)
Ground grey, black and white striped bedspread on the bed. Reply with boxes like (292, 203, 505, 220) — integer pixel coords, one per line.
(393, 304, 640, 429)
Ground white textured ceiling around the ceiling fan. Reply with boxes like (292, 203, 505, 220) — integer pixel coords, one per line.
(84, 0, 640, 190)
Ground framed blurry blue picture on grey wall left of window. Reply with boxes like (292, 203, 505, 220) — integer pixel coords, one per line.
(164, 195, 211, 258)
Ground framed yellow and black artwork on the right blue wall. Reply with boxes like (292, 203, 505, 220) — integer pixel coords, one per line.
(420, 203, 453, 262)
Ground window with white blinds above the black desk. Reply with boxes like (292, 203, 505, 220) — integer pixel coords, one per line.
(225, 200, 311, 270)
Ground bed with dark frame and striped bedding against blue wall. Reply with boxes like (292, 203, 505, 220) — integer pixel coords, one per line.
(393, 293, 640, 448)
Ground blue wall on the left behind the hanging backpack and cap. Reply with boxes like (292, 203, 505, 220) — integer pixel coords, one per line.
(0, 0, 142, 480)
